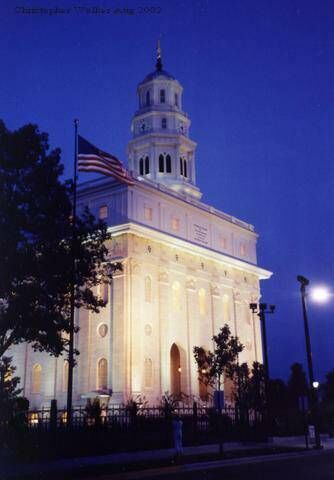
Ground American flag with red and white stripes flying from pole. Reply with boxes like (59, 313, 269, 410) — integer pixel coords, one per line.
(78, 135, 134, 185)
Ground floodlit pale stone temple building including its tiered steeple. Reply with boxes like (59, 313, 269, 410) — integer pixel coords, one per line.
(15, 50, 271, 407)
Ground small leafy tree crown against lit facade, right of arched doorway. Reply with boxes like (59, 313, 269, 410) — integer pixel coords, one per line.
(193, 324, 244, 398)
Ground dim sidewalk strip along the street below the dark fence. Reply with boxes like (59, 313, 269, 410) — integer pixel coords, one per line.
(0, 437, 334, 480)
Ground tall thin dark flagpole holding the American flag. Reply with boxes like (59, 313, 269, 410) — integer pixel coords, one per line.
(66, 119, 79, 427)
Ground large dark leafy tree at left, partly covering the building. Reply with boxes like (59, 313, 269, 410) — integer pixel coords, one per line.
(0, 122, 119, 357)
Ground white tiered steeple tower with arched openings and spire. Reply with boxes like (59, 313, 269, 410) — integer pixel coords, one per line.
(128, 45, 202, 198)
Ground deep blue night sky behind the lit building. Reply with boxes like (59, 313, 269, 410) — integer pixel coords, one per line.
(0, 0, 334, 378)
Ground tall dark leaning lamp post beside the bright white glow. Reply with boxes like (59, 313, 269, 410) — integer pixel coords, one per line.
(297, 275, 321, 448)
